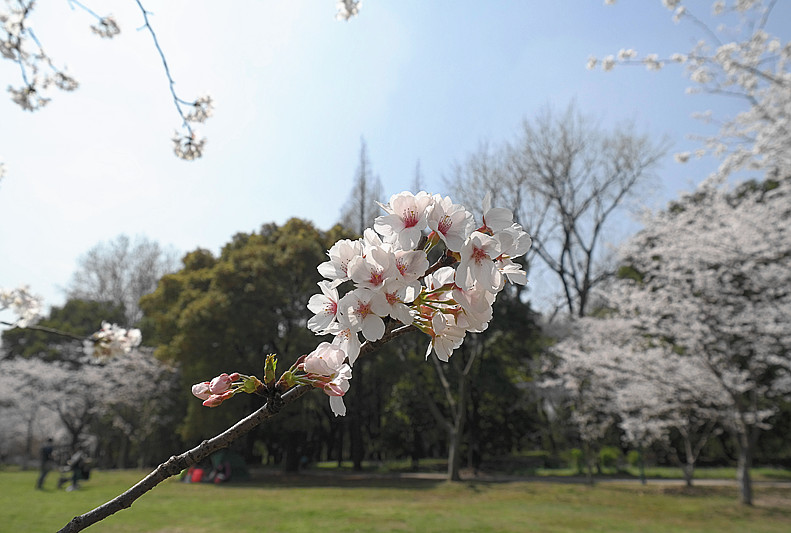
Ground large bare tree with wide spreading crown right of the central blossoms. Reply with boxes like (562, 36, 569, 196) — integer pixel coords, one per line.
(447, 103, 668, 316)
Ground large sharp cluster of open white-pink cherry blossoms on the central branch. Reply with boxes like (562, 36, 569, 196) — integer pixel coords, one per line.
(196, 191, 532, 416)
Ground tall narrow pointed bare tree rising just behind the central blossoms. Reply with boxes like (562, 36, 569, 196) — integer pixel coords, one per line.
(340, 138, 383, 235)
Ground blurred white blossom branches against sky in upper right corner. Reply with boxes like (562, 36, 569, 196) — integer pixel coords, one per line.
(587, 0, 791, 179)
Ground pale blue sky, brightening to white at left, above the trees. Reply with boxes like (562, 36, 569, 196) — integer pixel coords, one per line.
(0, 0, 791, 316)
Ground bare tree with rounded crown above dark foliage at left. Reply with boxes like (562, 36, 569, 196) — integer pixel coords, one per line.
(67, 235, 178, 326)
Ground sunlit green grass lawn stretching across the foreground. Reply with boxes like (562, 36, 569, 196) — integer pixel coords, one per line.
(6, 470, 791, 533)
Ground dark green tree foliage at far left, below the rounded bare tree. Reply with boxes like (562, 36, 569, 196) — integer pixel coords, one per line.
(3, 299, 124, 361)
